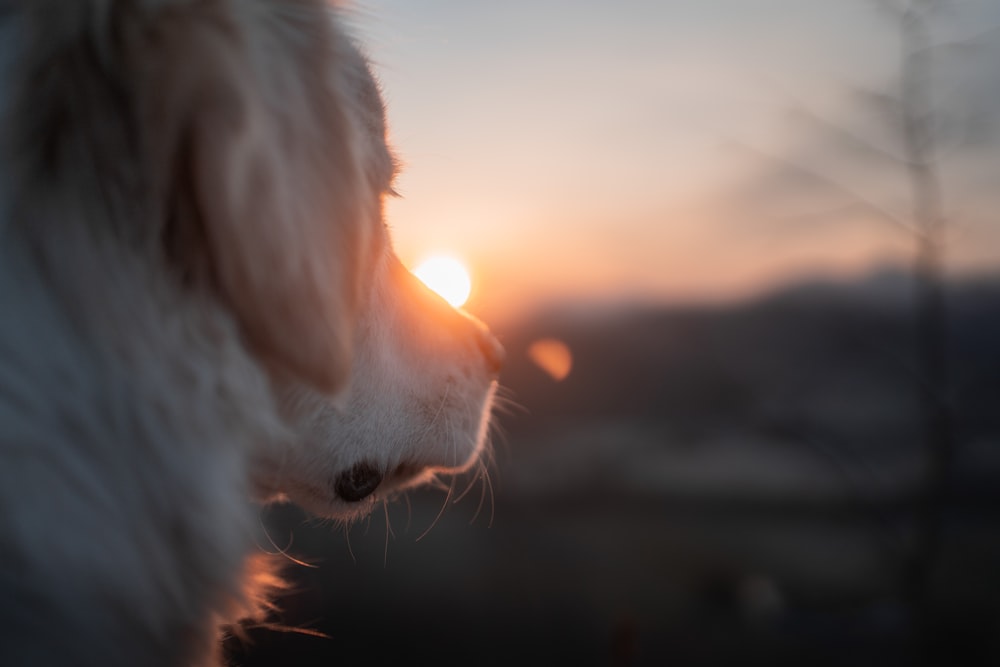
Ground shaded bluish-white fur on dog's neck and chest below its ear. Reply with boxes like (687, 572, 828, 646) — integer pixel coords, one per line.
(0, 220, 287, 665)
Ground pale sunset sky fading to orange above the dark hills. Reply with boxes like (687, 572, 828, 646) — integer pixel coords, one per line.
(351, 0, 1000, 324)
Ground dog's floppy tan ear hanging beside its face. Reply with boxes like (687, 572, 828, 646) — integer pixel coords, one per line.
(141, 2, 377, 392)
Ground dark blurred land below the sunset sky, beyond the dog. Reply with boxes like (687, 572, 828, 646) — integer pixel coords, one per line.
(227, 276, 1000, 667)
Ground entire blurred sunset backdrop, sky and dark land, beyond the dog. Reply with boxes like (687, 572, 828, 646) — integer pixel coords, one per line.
(228, 0, 1000, 665)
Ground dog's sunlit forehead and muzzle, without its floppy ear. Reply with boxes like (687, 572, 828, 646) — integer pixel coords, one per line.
(245, 11, 504, 518)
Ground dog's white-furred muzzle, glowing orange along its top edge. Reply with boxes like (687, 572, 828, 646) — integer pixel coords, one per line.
(273, 252, 502, 516)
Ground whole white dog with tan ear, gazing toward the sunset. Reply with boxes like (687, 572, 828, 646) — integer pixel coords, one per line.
(0, 0, 503, 667)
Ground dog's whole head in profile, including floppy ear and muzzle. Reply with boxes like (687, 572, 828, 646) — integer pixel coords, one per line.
(13, 0, 503, 517)
